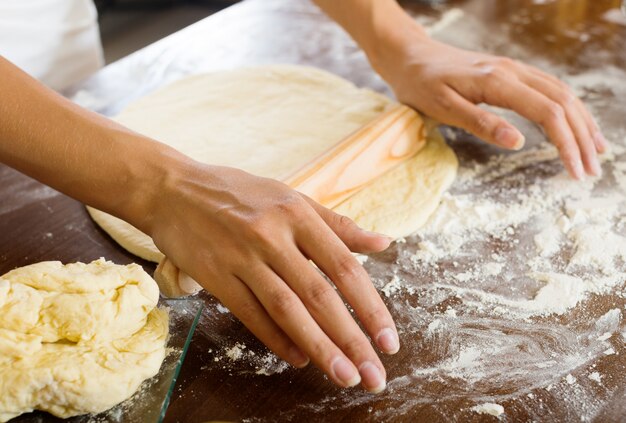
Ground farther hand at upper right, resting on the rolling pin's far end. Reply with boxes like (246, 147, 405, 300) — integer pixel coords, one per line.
(372, 34, 607, 179)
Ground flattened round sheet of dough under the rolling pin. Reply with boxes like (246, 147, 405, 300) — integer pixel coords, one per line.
(88, 65, 458, 262)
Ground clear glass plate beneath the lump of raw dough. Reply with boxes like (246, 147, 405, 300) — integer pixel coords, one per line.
(11, 298, 203, 423)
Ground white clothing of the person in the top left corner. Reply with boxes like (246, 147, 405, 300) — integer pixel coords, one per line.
(0, 0, 104, 90)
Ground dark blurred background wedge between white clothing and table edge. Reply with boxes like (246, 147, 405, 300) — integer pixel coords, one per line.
(95, 0, 239, 64)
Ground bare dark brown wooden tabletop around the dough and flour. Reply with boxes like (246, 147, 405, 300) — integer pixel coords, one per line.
(0, 0, 626, 422)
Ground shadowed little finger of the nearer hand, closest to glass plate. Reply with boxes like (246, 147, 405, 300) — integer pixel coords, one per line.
(211, 276, 310, 368)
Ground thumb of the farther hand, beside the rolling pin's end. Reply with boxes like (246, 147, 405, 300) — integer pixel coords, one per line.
(434, 88, 524, 150)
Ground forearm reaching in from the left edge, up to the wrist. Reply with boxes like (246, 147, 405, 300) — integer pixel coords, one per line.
(0, 57, 181, 229)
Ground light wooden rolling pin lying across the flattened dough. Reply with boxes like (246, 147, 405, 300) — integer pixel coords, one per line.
(154, 105, 426, 297)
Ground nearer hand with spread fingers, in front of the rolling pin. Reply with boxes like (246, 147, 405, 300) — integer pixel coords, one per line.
(141, 160, 399, 392)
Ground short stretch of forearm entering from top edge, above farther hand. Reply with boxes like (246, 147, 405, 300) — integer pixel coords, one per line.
(313, 0, 428, 73)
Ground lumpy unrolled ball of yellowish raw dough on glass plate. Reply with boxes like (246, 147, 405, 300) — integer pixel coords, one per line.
(0, 259, 168, 422)
